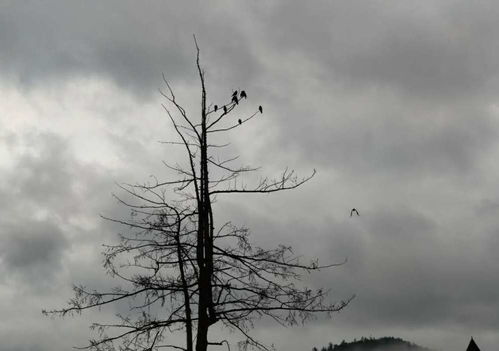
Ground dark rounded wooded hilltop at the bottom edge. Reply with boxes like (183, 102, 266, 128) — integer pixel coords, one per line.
(313, 336, 431, 351)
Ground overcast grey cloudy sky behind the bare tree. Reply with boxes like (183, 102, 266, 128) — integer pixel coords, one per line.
(0, 0, 499, 351)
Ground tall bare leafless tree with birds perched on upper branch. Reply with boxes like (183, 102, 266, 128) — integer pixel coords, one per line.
(44, 38, 351, 351)
